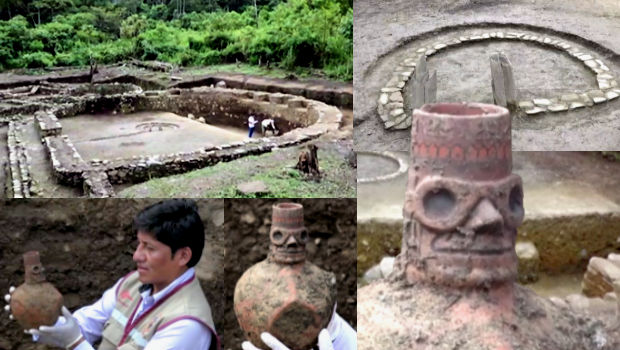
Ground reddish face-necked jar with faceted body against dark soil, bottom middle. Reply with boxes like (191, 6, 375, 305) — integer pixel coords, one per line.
(234, 203, 336, 350)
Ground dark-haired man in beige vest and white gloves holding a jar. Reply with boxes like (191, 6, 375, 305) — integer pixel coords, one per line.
(5, 199, 220, 350)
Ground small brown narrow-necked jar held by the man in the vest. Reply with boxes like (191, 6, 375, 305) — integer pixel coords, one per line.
(11, 251, 63, 329)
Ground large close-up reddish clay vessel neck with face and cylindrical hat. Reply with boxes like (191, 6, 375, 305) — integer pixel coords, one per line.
(403, 104, 524, 287)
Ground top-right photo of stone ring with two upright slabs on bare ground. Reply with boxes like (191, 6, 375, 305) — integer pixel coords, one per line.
(354, 0, 620, 151)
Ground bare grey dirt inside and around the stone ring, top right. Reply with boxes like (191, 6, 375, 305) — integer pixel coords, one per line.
(354, 0, 620, 151)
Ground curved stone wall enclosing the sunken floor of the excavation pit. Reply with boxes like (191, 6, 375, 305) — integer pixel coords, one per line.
(30, 88, 342, 197)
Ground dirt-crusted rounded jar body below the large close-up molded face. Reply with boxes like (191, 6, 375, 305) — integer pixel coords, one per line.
(358, 276, 620, 350)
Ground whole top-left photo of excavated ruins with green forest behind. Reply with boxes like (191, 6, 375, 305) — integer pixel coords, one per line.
(0, 0, 355, 198)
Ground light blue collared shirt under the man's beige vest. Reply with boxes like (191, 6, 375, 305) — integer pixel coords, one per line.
(73, 267, 211, 350)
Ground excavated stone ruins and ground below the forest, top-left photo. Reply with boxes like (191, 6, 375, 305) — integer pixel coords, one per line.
(0, 67, 355, 197)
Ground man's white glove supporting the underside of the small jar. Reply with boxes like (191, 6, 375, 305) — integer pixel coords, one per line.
(24, 306, 84, 348)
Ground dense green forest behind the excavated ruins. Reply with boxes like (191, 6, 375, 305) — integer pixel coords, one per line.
(0, 0, 353, 81)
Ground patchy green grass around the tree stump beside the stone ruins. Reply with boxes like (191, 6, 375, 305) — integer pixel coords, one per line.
(118, 144, 356, 198)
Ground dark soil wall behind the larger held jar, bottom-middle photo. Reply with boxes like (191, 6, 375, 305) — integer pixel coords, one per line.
(222, 199, 357, 350)
